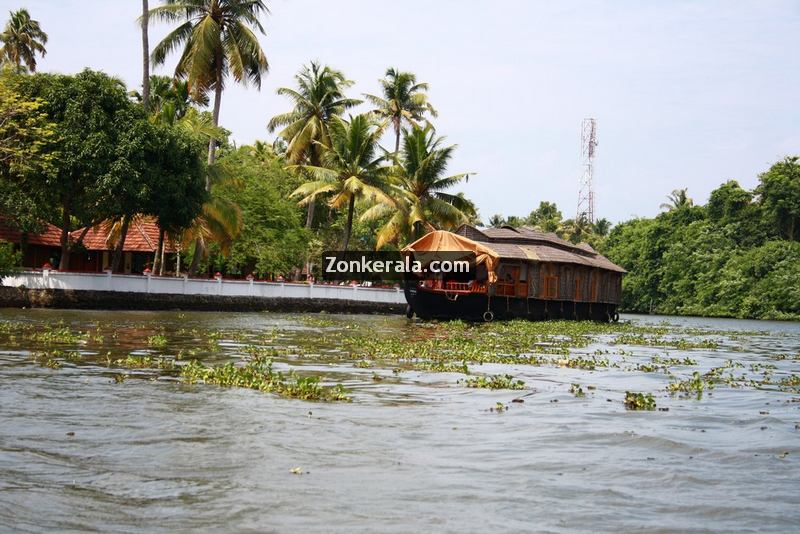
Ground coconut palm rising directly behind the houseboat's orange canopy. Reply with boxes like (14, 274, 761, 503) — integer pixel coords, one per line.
(361, 126, 474, 248)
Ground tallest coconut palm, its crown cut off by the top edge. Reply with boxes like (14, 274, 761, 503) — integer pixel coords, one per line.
(149, 0, 269, 168)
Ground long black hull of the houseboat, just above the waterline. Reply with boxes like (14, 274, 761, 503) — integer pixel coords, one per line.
(405, 284, 619, 322)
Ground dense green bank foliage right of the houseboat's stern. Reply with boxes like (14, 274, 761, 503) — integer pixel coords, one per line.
(600, 163, 800, 319)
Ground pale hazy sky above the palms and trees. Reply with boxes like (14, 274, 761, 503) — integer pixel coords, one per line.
(0, 0, 800, 222)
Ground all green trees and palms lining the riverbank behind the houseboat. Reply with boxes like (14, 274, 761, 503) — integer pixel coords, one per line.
(0, 4, 800, 319)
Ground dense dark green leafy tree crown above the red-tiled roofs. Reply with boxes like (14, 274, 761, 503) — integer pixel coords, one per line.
(10, 70, 205, 268)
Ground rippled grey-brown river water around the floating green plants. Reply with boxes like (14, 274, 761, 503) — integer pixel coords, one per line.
(0, 310, 800, 532)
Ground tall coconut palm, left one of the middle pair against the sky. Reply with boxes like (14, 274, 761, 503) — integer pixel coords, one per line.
(267, 61, 361, 228)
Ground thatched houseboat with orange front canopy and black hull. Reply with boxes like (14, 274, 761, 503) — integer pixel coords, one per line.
(403, 224, 626, 321)
